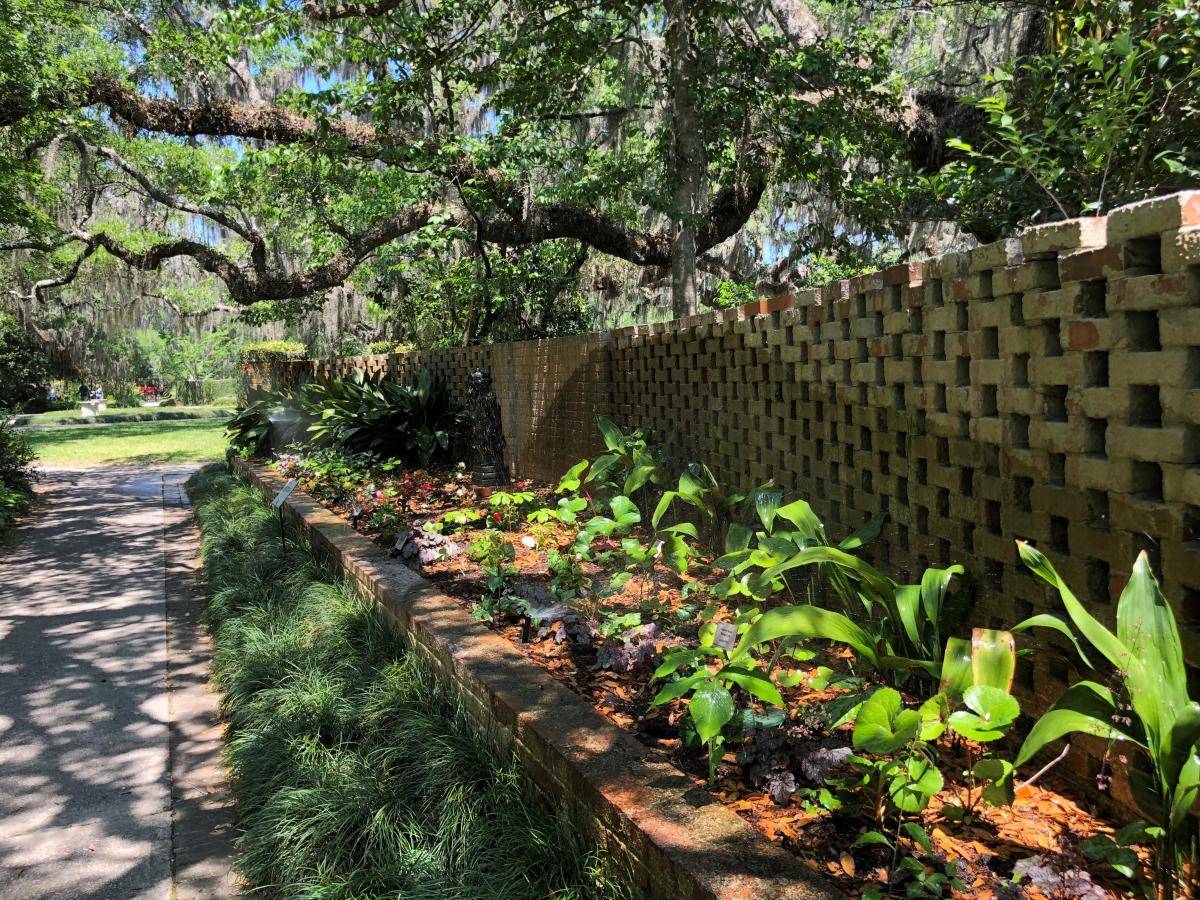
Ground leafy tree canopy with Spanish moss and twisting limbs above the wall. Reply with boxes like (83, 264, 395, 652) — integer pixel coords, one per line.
(0, 0, 1200, 342)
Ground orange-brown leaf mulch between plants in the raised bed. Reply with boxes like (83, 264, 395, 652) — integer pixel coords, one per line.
(280, 473, 1146, 898)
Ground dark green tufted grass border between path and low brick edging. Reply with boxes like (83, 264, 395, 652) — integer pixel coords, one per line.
(188, 466, 625, 900)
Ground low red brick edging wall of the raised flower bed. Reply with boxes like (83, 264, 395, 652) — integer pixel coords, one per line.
(233, 458, 844, 900)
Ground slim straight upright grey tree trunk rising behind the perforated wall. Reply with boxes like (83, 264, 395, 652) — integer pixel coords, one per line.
(666, 0, 707, 318)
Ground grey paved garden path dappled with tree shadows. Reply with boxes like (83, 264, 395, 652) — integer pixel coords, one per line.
(0, 467, 236, 900)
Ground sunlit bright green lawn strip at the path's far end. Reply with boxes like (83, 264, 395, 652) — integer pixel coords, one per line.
(25, 419, 226, 466)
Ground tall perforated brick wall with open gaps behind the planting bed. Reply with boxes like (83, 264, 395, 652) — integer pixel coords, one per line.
(243, 192, 1200, 772)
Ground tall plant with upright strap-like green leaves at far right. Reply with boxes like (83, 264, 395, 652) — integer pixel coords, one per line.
(1016, 541, 1200, 900)
